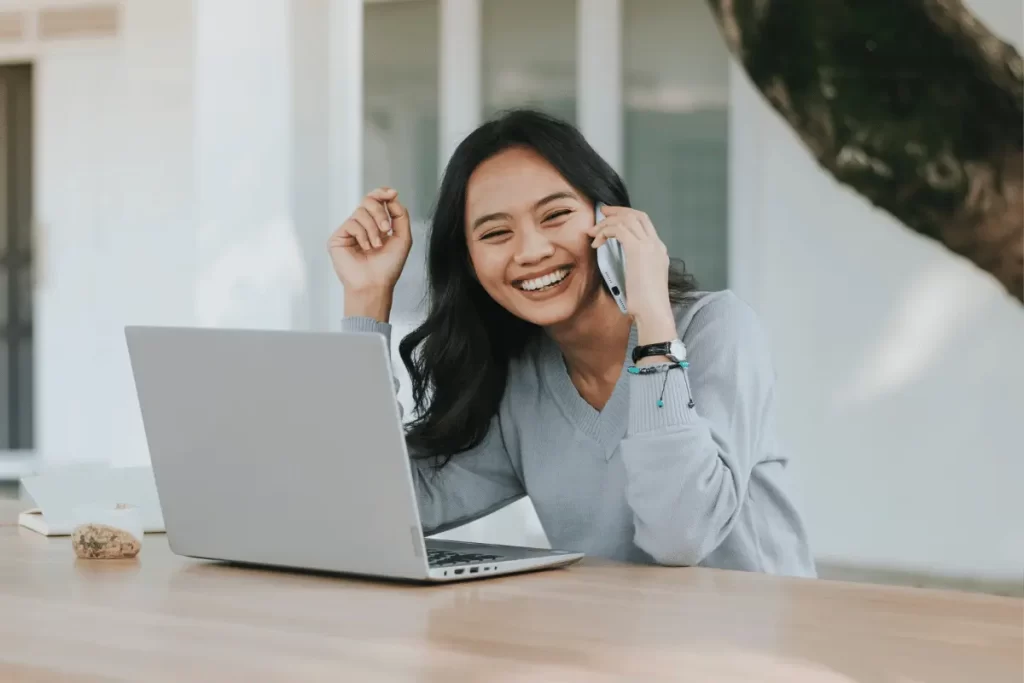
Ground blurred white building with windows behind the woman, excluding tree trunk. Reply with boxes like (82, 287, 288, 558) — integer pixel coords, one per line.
(0, 0, 1024, 593)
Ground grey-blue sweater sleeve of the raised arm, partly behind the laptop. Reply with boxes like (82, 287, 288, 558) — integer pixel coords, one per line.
(342, 317, 526, 536)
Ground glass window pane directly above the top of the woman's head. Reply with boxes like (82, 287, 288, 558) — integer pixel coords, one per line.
(481, 0, 577, 122)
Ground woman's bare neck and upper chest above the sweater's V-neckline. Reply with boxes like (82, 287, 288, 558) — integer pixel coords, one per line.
(547, 292, 633, 379)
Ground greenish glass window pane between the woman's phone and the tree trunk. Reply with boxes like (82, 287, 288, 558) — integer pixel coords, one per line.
(623, 0, 729, 289)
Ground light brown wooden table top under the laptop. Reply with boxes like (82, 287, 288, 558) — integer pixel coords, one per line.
(0, 502, 1024, 683)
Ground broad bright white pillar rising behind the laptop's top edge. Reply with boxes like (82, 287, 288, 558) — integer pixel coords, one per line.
(191, 0, 305, 329)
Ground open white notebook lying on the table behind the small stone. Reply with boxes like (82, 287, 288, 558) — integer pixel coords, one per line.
(17, 465, 164, 536)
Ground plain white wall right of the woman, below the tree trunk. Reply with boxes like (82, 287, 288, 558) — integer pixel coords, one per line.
(731, 0, 1024, 580)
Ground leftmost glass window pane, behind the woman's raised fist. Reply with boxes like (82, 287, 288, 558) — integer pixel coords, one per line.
(362, 0, 439, 325)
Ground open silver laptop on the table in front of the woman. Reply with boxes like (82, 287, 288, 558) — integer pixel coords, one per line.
(125, 327, 583, 582)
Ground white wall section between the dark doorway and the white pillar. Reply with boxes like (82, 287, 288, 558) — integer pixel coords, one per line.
(34, 0, 196, 471)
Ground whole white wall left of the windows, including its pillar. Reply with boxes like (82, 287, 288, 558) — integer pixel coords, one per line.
(20, 0, 339, 468)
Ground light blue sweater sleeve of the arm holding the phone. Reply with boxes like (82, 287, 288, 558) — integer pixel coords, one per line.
(621, 294, 774, 566)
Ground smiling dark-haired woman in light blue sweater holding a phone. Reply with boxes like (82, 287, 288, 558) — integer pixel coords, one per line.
(329, 111, 814, 575)
